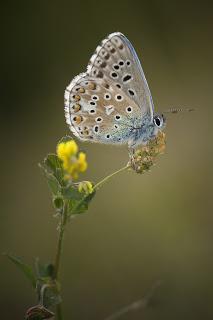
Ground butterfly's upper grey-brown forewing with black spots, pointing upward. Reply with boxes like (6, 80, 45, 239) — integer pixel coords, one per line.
(87, 32, 153, 118)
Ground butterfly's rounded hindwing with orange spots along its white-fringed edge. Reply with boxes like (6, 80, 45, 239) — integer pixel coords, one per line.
(65, 74, 141, 144)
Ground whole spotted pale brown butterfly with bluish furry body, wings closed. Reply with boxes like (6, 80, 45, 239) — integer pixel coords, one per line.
(64, 32, 165, 149)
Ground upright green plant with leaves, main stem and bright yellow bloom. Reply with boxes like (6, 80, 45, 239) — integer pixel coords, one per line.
(6, 137, 95, 320)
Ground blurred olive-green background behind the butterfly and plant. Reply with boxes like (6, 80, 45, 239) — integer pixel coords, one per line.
(0, 0, 213, 320)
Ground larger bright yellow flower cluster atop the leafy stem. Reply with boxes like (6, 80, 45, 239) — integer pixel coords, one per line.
(57, 140, 88, 180)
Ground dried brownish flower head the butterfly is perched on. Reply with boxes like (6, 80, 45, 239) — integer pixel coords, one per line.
(129, 131, 166, 173)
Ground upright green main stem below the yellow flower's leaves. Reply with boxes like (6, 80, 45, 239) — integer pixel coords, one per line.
(54, 200, 68, 320)
